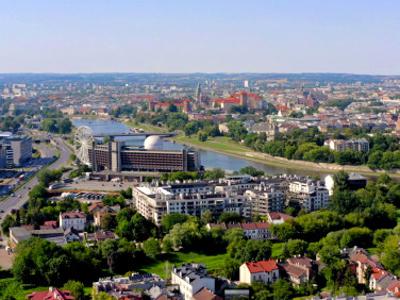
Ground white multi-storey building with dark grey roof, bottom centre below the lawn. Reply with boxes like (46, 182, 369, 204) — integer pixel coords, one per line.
(171, 264, 215, 300)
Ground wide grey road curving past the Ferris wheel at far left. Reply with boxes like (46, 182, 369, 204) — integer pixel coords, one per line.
(0, 137, 71, 219)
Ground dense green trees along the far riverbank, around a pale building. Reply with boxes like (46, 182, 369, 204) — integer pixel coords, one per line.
(239, 121, 400, 170)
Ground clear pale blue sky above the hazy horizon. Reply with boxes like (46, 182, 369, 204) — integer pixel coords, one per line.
(0, 0, 400, 75)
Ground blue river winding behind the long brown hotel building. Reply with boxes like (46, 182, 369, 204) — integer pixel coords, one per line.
(72, 119, 317, 175)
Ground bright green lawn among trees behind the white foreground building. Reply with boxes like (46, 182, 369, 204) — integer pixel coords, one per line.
(141, 252, 227, 278)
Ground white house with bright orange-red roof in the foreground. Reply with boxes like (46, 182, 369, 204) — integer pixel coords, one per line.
(239, 259, 279, 284)
